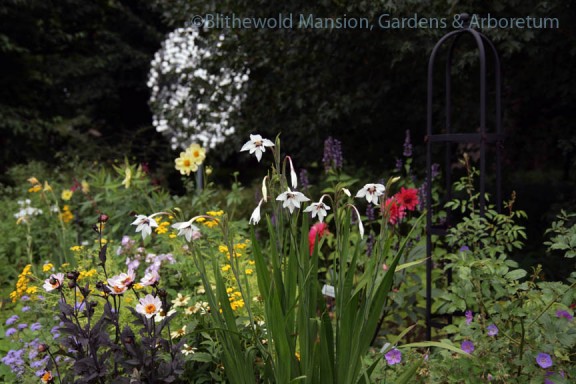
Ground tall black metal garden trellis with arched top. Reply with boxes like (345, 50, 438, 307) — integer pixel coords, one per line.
(425, 15, 504, 340)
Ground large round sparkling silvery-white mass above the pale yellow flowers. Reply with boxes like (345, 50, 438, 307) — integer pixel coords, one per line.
(147, 27, 249, 149)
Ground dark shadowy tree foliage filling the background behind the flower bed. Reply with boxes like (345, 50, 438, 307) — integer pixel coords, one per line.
(0, 0, 576, 268)
